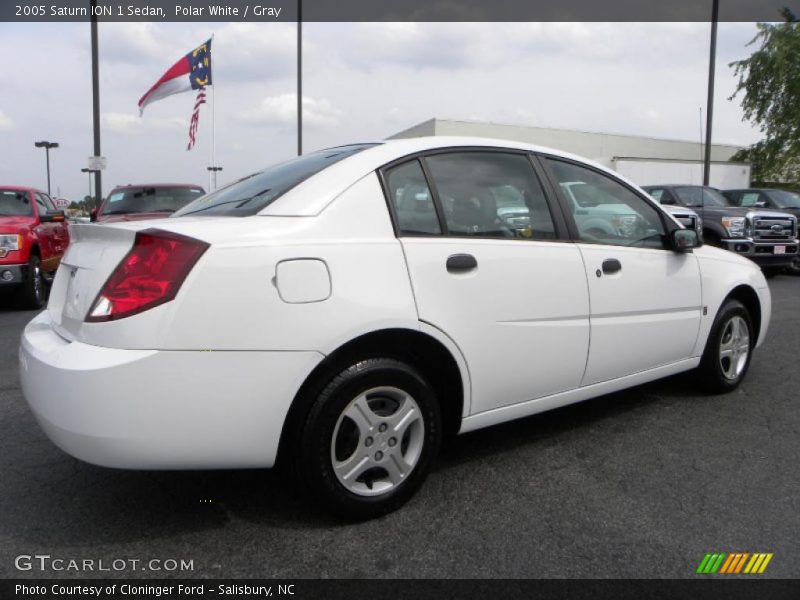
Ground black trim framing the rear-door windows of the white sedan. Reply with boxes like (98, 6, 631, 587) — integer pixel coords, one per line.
(376, 146, 574, 244)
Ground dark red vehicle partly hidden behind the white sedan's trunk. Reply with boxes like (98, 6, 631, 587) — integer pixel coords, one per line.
(91, 183, 205, 223)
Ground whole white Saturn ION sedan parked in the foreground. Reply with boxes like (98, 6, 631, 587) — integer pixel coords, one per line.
(20, 138, 770, 519)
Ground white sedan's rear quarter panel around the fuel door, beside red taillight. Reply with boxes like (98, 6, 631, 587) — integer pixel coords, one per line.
(76, 173, 420, 353)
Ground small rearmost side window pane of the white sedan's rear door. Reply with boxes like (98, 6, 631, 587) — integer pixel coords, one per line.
(386, 160, 442, 235)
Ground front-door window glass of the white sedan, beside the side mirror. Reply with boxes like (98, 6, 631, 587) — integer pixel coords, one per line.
(547, 158, 666, 248)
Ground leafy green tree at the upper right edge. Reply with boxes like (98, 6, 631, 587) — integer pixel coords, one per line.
(729, 8, 800, 182)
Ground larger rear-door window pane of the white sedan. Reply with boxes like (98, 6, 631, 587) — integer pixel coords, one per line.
(425, 151, 556, 239)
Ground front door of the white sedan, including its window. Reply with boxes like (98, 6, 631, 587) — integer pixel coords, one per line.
(543, 157, 702, 385)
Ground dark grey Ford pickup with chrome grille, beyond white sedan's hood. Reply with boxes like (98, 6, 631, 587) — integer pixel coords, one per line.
(642, 185, 800, 273)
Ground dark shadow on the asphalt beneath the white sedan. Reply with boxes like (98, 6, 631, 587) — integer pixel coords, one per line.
(0, 376, 708, 547)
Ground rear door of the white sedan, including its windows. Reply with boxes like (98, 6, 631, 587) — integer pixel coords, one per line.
(382, 149, 589, 414)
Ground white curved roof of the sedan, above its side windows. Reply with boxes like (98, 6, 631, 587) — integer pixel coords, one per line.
(266, 136, 638, 216)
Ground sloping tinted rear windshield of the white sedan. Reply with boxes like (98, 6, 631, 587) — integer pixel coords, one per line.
(173, 144, 375, 217)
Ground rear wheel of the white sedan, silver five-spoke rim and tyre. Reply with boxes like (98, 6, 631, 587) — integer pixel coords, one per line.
(294, 358, 441, 521)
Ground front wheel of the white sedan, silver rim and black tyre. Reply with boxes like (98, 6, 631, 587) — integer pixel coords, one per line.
(697, 299, 755, 394)
